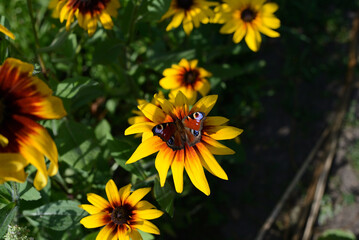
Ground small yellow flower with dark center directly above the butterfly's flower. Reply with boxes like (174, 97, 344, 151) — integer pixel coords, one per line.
(160, 59, 211, 105)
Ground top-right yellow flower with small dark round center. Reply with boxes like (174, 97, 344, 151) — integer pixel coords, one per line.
(213, 0, 280, 52)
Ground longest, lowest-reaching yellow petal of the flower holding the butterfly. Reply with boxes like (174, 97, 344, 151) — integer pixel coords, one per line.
(184, 147, 211, 196)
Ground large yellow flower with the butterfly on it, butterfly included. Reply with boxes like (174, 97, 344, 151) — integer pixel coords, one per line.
(125, 92, 243, 195)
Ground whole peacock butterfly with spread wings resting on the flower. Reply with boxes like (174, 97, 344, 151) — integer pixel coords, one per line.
(152, 112, 206, 150)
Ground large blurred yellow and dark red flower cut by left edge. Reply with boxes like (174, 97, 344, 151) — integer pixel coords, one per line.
(0, 58, 66, 190)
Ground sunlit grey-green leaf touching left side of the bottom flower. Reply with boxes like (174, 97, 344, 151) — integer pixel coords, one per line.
(23, 200, 87, 231)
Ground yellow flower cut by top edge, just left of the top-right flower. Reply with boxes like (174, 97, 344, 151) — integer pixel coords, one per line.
(161, 0, 218, 35)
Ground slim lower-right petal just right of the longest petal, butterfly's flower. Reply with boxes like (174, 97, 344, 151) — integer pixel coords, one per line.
(196, 142, 228, 180)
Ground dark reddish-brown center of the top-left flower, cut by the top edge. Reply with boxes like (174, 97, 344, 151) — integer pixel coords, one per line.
(68, 0, 110, 14)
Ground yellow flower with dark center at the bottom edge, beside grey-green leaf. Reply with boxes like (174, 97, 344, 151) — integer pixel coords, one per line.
(79, 180, 163, 240)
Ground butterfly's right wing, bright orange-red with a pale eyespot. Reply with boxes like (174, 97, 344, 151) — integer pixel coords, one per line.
(182, 112, 206, 147)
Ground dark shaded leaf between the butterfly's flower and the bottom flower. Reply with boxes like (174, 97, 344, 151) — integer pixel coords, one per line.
(154, 178, 176, 217)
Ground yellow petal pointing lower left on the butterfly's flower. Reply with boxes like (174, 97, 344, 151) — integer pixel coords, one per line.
(126, 136, 167, 164)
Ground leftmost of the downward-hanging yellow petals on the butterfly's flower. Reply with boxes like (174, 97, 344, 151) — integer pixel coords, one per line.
(155, 147, 175, 187)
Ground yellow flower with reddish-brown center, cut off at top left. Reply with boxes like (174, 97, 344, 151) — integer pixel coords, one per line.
(49, 0, 120, 36)
